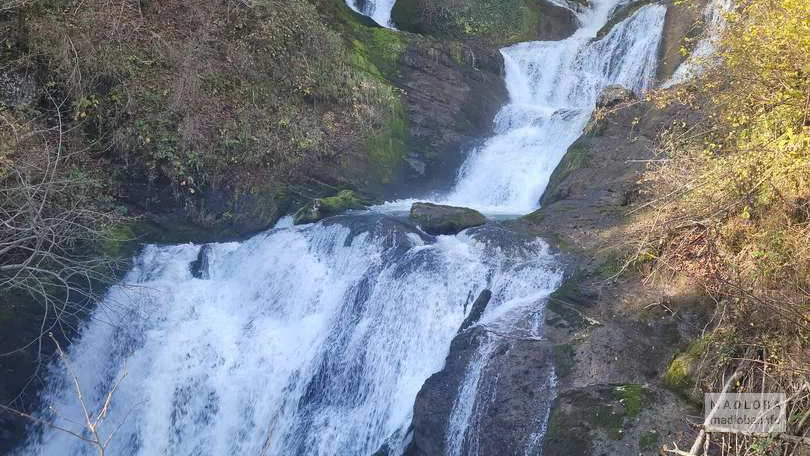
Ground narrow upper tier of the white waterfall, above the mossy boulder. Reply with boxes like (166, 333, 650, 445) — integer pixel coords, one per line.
(442, 2, 666, 214)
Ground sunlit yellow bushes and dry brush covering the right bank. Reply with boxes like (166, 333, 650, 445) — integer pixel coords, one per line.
(631, 0, 810, 454)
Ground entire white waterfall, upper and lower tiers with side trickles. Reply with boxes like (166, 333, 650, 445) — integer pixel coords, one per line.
(20, 0, 664, 456)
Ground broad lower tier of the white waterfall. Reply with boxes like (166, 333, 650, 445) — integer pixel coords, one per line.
(22, 219, 560, 455)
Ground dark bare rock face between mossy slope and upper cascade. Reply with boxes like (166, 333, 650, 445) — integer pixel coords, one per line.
(392, 35, 507, 196)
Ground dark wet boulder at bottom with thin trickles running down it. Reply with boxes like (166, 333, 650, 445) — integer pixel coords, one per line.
(406, 327, 553, 456)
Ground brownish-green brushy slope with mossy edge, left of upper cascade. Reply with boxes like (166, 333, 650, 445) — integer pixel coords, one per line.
(19, 0, 408, 232)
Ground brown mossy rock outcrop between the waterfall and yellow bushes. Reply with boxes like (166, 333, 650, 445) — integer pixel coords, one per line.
(517, 102, 710, 456)
